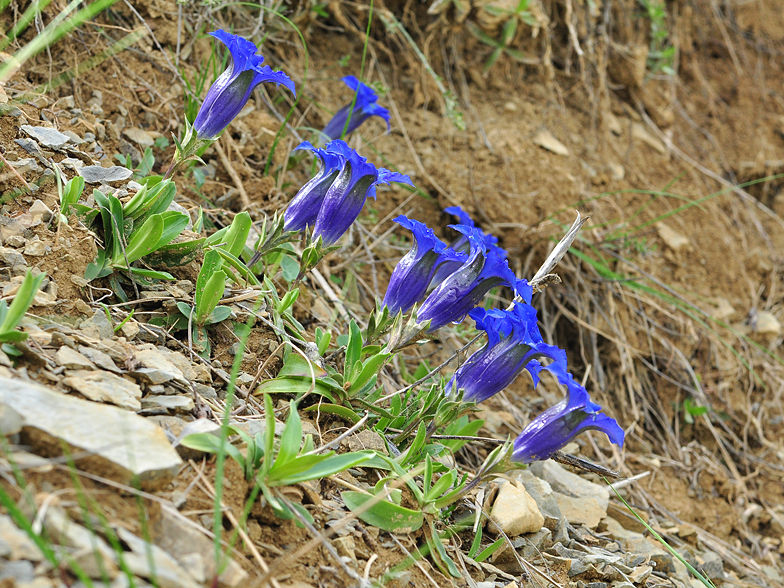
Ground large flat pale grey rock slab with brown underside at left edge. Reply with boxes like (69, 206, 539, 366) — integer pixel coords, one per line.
(0, 377, 182, 489)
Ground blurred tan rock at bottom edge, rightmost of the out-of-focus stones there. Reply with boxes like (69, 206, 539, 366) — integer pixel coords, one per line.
(152, 509, 248, 588)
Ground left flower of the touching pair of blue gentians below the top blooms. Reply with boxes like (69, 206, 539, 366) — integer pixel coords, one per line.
(283, 141, 345, 231)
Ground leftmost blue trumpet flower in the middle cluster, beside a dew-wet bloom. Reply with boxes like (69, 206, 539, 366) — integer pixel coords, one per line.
(384, 216, 468, 315)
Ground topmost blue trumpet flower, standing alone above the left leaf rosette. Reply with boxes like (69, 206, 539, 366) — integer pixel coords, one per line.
(193, 30, 296, 139)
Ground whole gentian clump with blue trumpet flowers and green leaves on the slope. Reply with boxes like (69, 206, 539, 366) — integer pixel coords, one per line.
(70, 26, 624, 577)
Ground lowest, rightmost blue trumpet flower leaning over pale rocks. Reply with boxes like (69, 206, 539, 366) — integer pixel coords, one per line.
(512, 366, 624, 463)
